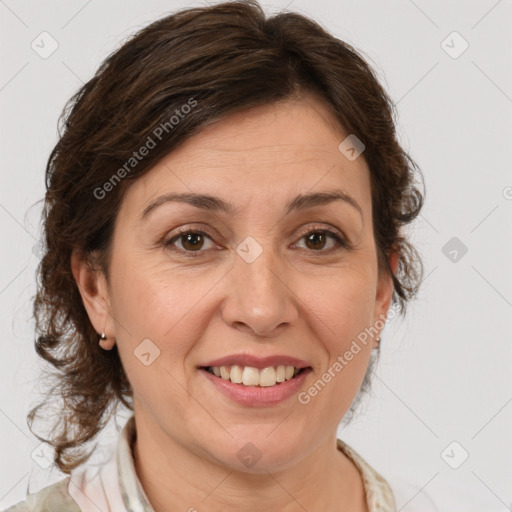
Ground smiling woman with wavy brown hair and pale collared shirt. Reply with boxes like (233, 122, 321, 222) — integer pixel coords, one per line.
(9, 1, 423, 512)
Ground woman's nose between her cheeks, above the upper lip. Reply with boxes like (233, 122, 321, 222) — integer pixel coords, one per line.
(222, 242, 299, 338)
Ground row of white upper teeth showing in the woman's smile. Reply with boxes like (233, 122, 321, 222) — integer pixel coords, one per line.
(209, 365, 300, 387)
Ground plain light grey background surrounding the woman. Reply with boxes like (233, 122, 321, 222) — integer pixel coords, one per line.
(0, 0, 512, 512)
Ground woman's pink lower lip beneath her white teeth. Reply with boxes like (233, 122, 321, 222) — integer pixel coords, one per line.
(200, 368, 312, 407)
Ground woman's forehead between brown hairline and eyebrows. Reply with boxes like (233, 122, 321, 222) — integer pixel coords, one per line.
(123, 97, 370, 218)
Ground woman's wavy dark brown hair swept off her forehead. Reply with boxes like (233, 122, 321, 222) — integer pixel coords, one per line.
(28, 0, 423, 473)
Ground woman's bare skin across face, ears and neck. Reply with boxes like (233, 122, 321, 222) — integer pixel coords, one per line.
(72, 96, 398, 512)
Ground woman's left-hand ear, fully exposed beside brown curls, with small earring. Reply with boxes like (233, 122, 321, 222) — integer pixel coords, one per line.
(71, 250, 115, 350)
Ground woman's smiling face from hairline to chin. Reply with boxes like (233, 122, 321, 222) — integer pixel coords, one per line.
(77, 97, 392, 471)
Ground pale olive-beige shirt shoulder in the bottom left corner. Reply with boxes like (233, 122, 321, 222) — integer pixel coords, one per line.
(4, 476, 80, 512)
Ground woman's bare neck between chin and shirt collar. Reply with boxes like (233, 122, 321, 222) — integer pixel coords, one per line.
(133, 412, 367, 512)
